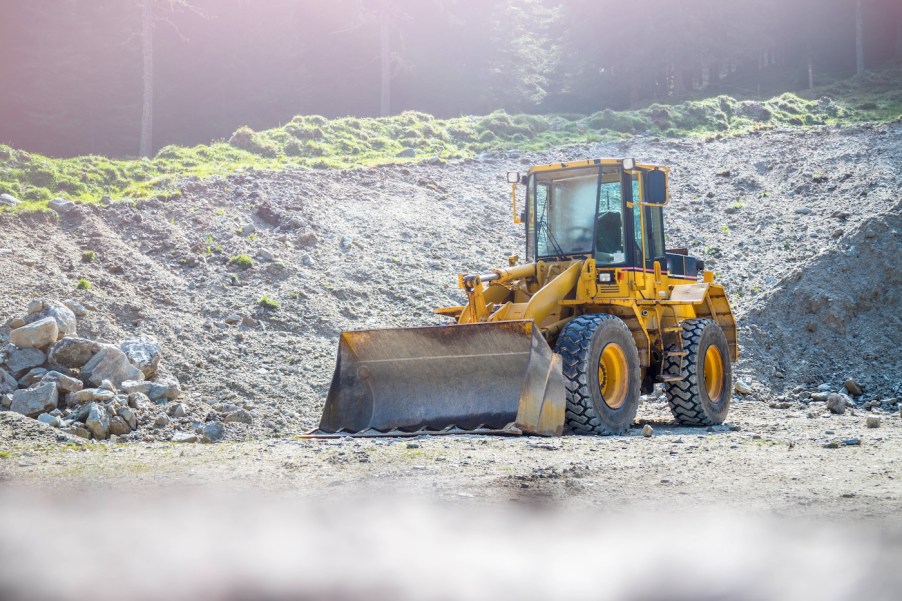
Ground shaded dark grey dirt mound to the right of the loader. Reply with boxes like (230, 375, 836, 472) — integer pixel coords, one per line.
(744, 203, 902, 399)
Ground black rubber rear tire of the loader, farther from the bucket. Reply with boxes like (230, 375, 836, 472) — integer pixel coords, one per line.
(664, 319, 733, 426)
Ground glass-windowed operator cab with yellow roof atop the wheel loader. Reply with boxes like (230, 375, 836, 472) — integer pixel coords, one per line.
(511, 159, 702, 280)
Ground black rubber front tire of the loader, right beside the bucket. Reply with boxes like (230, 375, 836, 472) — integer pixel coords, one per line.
(555, 313, 641, 434)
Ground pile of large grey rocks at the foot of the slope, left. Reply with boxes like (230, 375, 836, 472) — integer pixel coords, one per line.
(0, 299, 184, 440)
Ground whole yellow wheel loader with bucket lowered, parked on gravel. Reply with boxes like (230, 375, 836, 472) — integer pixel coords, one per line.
(311, 159, 737, 436)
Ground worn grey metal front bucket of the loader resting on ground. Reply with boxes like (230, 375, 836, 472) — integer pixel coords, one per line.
(314, 321, 565, 436)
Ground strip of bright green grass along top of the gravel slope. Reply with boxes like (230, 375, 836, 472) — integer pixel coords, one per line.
(0, 66, 902, 212)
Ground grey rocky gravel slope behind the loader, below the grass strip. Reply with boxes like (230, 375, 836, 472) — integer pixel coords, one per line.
(0, 122, 902, 438)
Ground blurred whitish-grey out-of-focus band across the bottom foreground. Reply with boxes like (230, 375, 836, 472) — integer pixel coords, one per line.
(0, 488, 902, 601)
